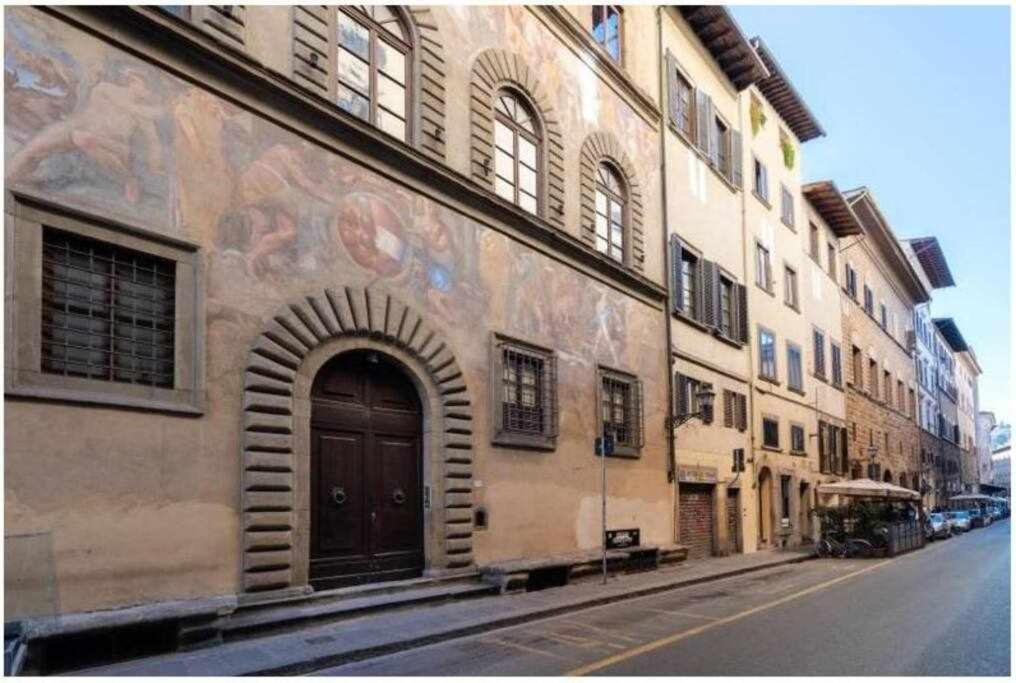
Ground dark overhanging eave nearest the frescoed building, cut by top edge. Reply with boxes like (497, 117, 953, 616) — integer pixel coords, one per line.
(676, 5, 769, 90)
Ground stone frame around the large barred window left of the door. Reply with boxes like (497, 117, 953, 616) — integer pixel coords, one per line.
(4, 193, 205, 416)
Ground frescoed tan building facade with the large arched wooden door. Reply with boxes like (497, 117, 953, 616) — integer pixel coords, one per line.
(5, 7, 678, 617)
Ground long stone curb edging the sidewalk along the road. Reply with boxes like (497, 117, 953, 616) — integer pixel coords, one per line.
(256, 555, 816, 676)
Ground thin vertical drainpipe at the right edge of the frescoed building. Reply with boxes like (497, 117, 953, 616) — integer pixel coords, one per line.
(656, 5, 678, 542)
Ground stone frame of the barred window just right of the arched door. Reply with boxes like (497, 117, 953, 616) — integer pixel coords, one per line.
(490, 332, 561, 450)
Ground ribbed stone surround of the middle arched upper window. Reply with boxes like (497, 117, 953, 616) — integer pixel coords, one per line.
(469, 49, 565, 228)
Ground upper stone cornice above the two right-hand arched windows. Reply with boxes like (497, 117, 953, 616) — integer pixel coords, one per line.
(528, 5, 662, 126)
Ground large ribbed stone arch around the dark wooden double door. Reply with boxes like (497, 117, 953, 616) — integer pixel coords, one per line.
(241, 287, 472, 592)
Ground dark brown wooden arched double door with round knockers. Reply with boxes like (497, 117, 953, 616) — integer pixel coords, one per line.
(310, 352, 424, 589)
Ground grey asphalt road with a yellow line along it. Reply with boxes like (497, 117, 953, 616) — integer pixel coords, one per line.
(317, 520, 1010, 676)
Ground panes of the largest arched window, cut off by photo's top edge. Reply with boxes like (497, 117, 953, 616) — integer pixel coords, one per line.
(335, 5, 412, 141)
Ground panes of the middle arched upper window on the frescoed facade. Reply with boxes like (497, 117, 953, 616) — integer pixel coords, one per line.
(494, 89, 543, 213)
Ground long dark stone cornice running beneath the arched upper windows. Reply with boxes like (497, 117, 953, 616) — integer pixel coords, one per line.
(39, 6, 666, 307)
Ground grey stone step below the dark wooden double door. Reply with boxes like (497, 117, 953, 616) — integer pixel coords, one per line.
(217, 578, 497, 641)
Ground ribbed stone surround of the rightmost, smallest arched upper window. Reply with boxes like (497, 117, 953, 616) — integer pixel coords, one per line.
(579, 132, 645, 270)
